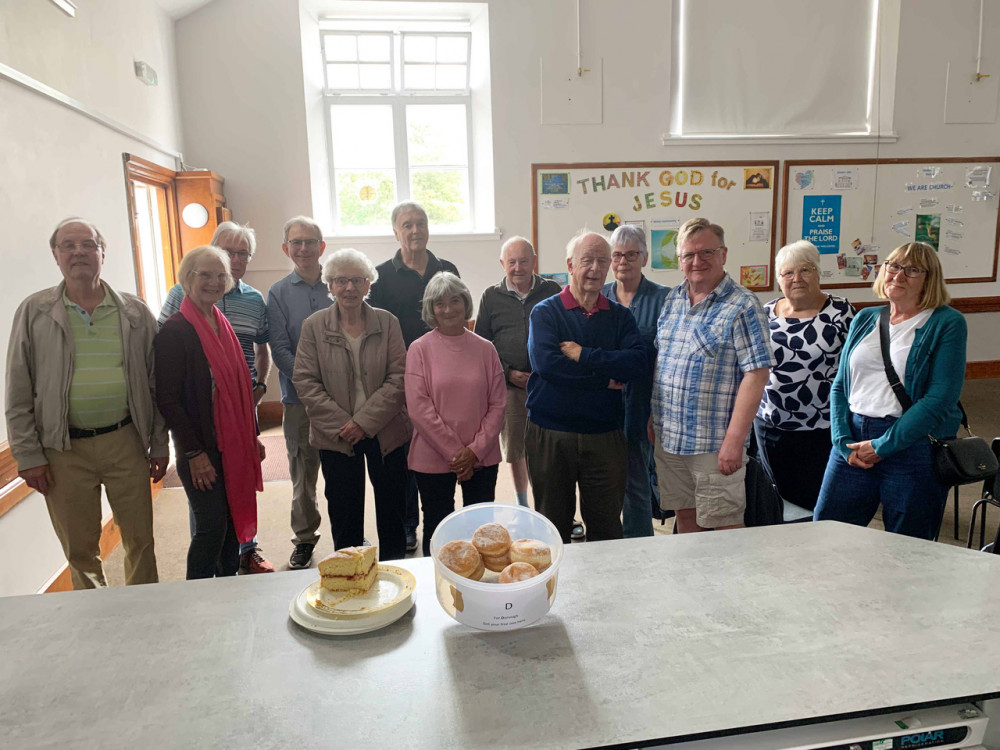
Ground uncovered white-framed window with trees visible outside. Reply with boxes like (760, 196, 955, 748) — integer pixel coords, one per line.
(320, 21, 474, 234)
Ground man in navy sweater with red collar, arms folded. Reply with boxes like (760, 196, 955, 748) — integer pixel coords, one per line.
(525, 232, 648, 543)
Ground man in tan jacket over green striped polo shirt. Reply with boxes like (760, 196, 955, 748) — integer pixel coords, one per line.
(6, 218, 168, 589)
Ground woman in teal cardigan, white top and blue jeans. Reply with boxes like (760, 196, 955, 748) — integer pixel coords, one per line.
(813, 242, 966, 539)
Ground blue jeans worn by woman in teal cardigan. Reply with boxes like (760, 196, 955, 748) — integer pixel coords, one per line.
(813, 414, 949, 539)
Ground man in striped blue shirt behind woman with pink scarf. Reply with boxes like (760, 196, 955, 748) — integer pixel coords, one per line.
(162, 221, 274, 573)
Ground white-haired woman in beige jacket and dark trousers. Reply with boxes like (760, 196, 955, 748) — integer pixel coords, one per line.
(292, 248, 411, 560)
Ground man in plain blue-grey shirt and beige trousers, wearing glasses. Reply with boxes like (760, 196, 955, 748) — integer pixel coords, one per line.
(267, 216, 333, 568)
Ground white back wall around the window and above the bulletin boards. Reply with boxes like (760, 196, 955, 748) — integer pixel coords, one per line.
(177, 0, 1000, 360)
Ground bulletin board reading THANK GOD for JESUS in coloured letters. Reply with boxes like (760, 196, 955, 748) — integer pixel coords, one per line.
(531, 161, 778, 291)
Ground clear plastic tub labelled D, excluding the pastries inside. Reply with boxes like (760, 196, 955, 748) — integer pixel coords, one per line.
(430, 503, 563, 630)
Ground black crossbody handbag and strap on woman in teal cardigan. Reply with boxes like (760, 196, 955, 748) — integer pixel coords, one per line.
(878, 305, 1000, 487)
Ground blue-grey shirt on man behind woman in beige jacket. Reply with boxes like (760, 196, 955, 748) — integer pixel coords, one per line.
(267, 271, 333, 404)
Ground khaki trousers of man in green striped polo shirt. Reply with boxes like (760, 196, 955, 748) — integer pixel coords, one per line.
(45, 424, 159, 589)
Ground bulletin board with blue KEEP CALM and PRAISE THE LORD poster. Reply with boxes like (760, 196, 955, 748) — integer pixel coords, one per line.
(782, 157, 1000, 288)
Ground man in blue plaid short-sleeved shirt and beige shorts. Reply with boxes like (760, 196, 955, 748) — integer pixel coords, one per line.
(649, 218, 775, 534)
